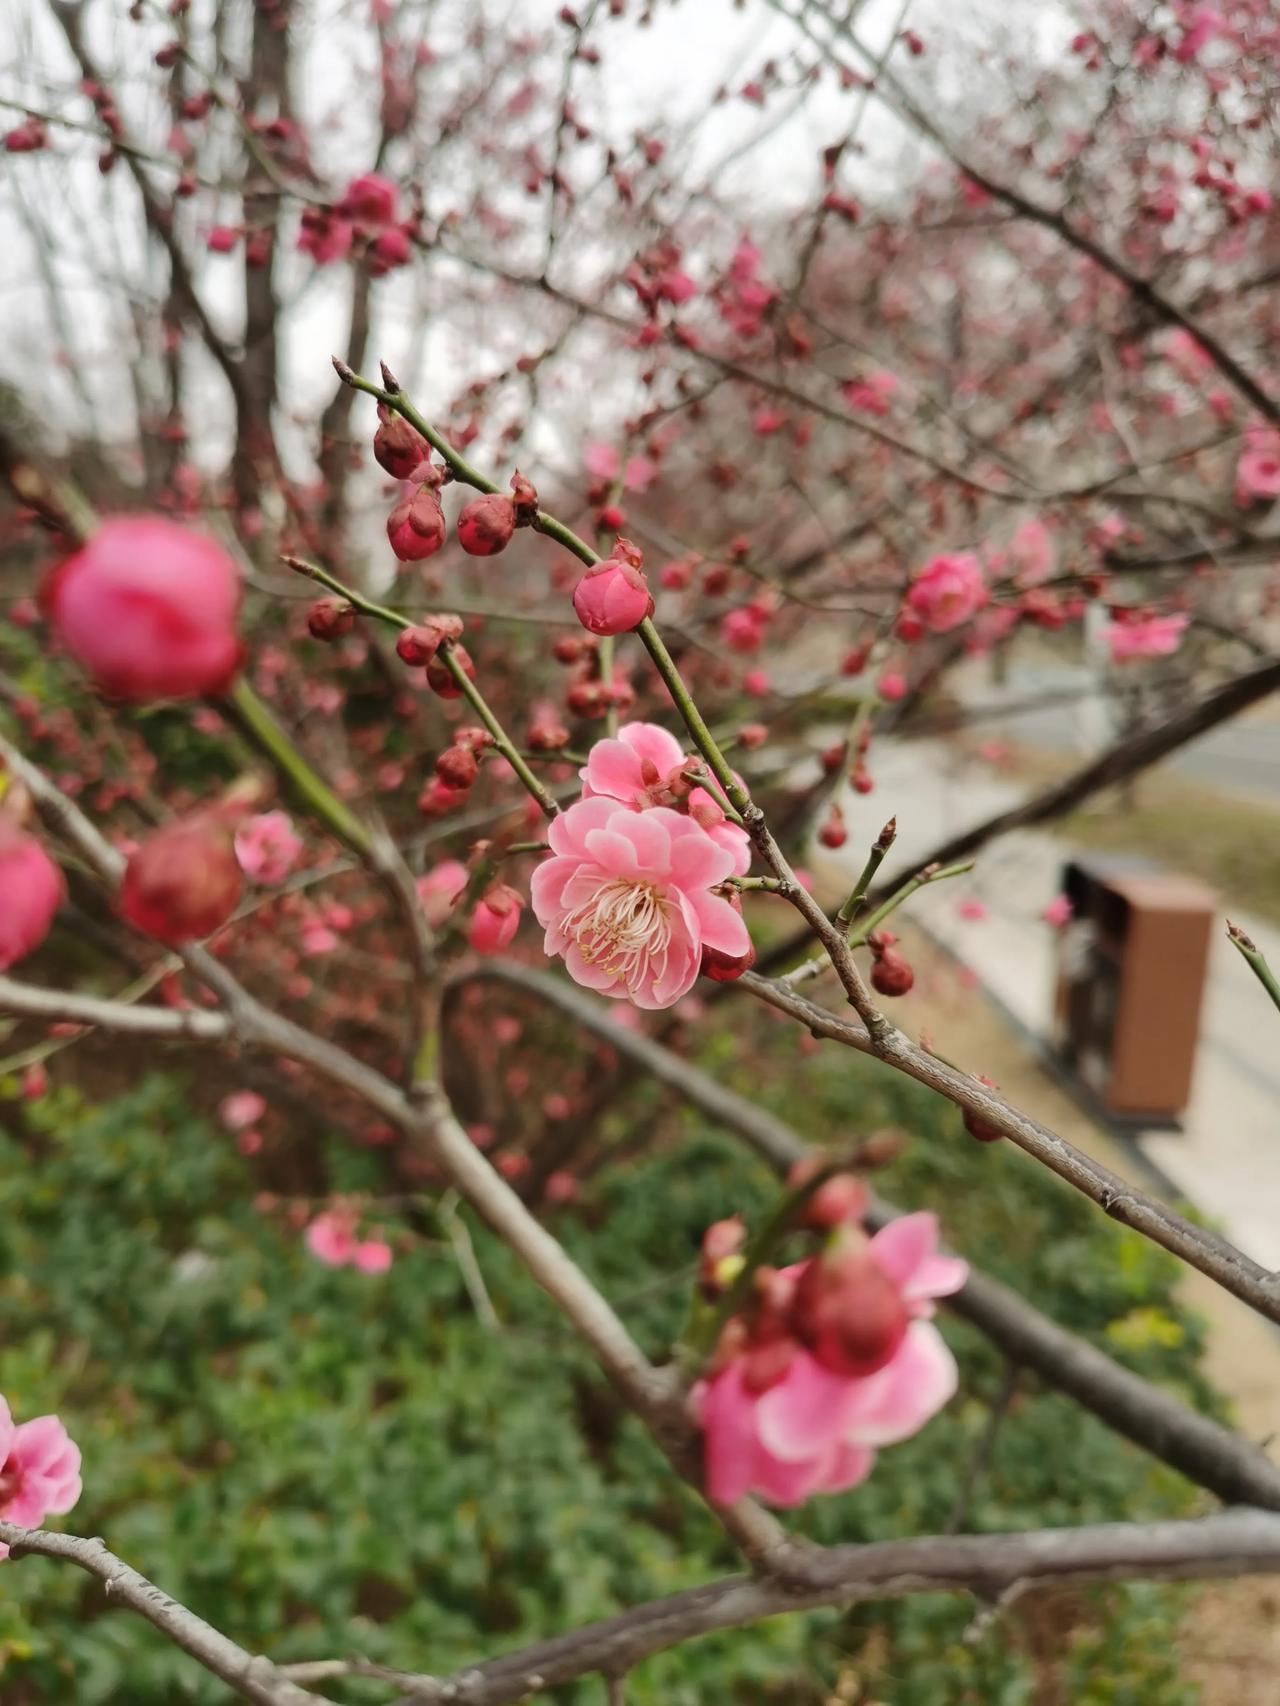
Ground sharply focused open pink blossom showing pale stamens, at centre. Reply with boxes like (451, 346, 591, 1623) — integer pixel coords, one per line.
(532, 797, 751, 1008)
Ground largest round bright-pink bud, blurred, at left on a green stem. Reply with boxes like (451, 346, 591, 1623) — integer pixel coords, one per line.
(41, 515, 241, 703)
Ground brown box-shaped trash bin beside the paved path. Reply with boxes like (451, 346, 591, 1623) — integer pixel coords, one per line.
(1055, 855, 1217, 1124)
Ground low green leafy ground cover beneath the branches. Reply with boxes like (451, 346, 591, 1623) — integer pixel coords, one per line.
(0, 1039, 1207, 1706)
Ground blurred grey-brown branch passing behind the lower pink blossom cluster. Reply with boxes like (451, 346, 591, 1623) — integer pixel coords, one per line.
(468, 959, 1280, 1510)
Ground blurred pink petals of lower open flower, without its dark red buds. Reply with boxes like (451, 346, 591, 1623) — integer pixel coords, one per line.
(691, 1213, 968, 1506)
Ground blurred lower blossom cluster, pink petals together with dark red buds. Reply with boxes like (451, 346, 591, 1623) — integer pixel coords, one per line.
(691, 1201, 968, 1506)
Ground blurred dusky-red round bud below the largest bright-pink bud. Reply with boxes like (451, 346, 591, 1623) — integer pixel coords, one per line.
(119, 814, 244, 947)
